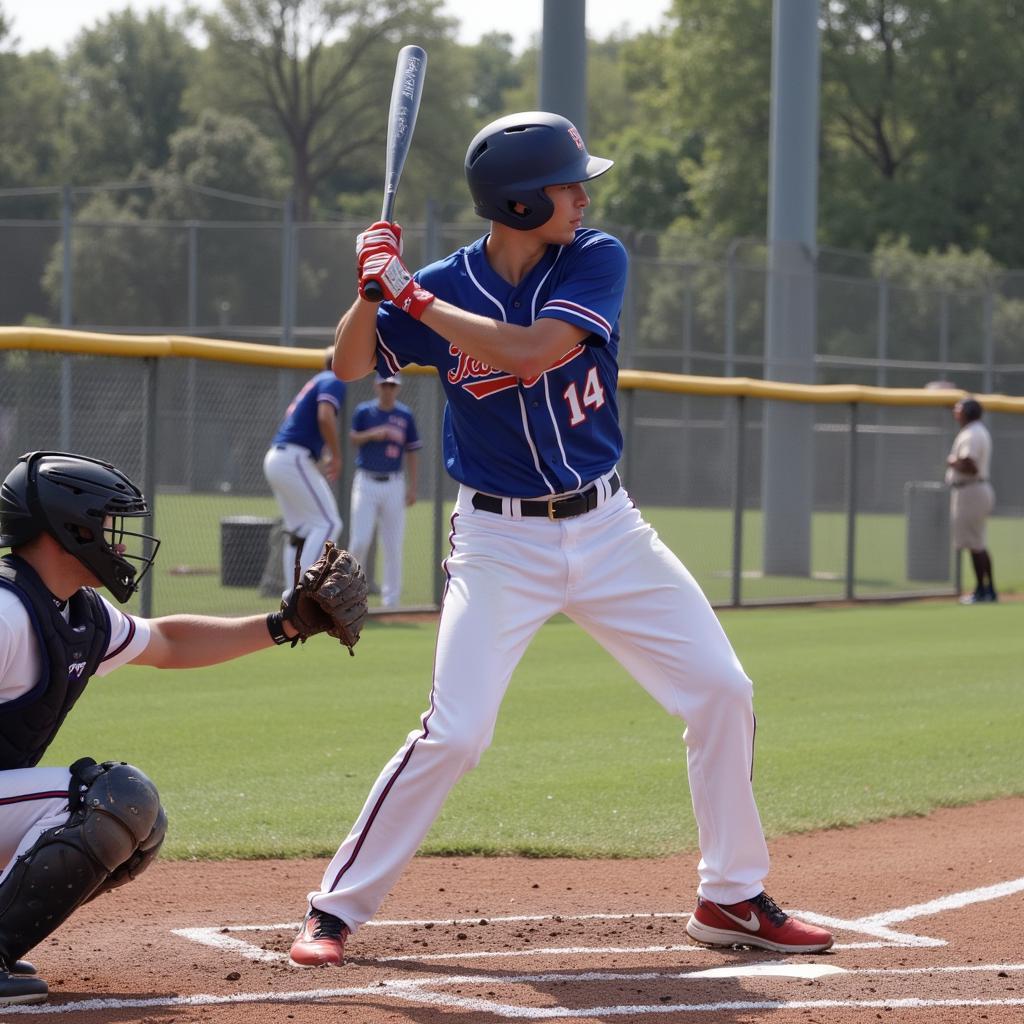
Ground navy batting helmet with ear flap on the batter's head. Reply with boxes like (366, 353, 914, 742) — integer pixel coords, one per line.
(466, 111, 612, 231)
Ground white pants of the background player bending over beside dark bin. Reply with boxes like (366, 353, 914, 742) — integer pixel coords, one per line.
(263, 444, 341, 591)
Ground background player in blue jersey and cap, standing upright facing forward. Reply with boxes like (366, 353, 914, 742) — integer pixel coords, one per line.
(348, 374, 423, 608)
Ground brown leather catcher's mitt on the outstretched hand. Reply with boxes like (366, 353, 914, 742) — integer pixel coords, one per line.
(281, 541, 369, 654)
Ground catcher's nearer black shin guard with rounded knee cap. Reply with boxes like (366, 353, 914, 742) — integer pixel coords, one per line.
(0, 758, 166, 964)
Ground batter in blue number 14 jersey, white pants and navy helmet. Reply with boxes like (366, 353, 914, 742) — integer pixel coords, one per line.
(291, 112, 833, 965)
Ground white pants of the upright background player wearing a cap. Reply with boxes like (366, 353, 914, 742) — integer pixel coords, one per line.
(348, 469, 406, 608)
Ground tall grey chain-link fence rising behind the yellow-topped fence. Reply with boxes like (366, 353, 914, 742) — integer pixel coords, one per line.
(0, 186, 1024, 394)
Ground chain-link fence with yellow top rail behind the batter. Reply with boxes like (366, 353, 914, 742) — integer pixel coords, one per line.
(0, 339, 1024, 614)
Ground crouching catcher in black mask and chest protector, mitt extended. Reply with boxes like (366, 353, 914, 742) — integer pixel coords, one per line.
(0, 452, 367, 1007)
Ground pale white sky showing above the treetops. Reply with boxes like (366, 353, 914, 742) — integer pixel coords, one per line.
(12, 0, 670, 53)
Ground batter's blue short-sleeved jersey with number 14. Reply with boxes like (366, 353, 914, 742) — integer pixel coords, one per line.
(377, 228, 627, 498)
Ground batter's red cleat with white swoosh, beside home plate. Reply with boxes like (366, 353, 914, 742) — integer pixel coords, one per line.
(686, 893, 833, 953)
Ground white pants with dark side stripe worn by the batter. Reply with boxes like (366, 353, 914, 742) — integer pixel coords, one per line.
(309, 475, 768, 931)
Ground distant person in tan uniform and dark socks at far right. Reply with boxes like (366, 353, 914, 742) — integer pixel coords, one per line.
(946, 398, 997, 604)
